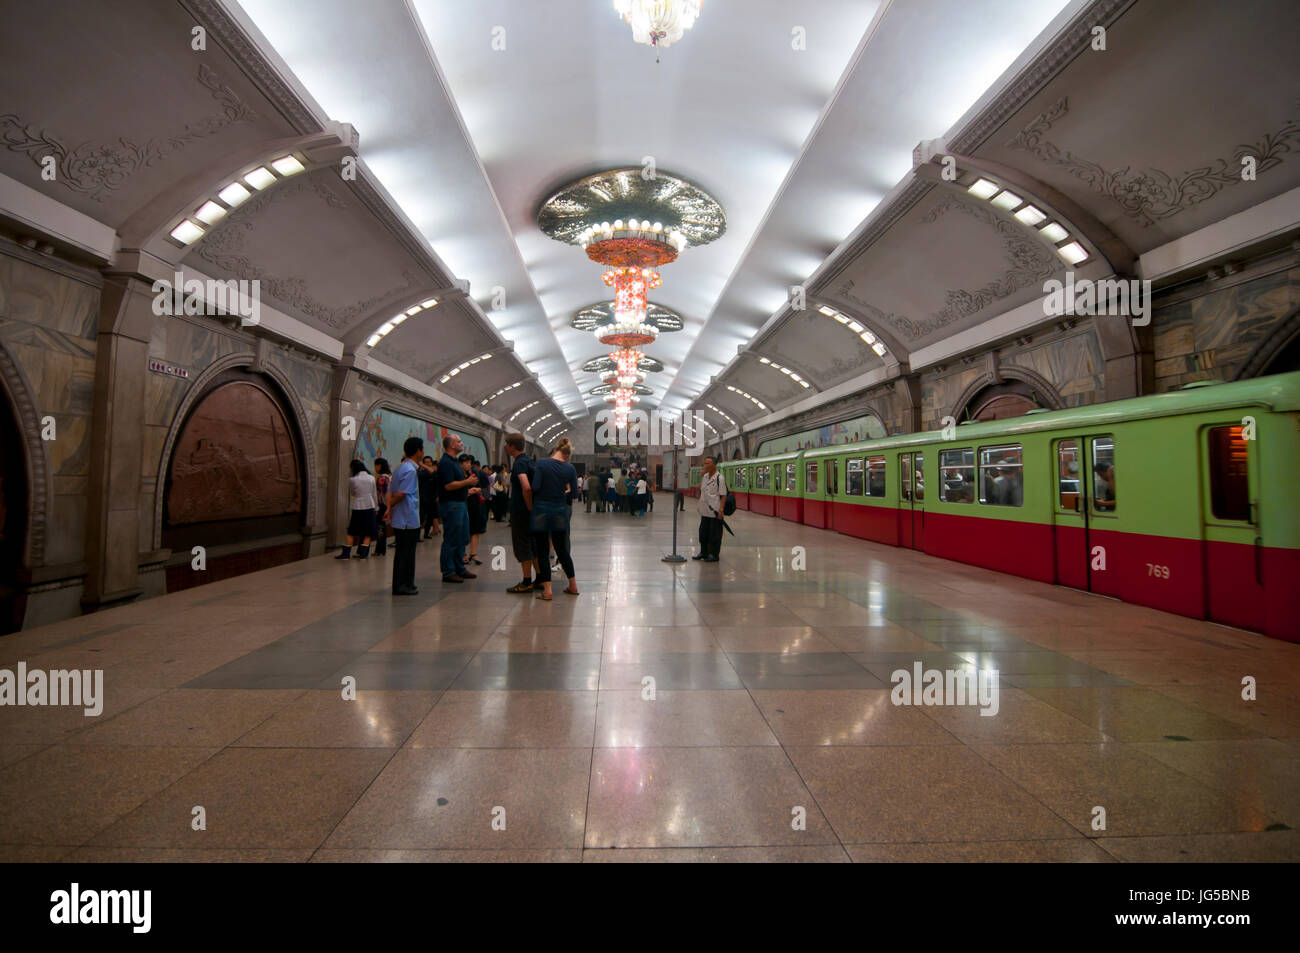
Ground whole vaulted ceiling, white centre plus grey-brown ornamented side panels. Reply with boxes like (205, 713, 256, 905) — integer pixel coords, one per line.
(0, 0, 1300, 439)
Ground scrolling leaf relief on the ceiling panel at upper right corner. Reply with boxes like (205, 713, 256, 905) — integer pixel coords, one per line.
(1006, 96, 1300, 228)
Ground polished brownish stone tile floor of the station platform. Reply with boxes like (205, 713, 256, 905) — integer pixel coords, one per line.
(0, 497, 1300, 862)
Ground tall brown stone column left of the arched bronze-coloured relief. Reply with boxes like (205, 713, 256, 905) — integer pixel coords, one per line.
(82, 274, 157, 608)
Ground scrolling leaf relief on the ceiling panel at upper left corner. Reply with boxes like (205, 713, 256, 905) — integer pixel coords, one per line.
(0, 64, 257, 202)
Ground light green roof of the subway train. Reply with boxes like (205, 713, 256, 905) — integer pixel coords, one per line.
(729, 371, 1300, 465)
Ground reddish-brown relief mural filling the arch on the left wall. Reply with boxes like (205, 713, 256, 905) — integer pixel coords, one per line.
(166, 381, 303, 527)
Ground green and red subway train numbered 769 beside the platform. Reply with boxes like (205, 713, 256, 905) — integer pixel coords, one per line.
(690, 372, 1300, 641)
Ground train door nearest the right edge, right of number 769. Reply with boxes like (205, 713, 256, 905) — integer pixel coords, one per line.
(1200, 424, 1268, 632)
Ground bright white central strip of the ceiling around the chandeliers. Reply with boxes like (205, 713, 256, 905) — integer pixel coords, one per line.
(231, 0, 1065, 415)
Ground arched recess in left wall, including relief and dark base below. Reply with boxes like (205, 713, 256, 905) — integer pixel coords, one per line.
(163, 368, 307, 592)
